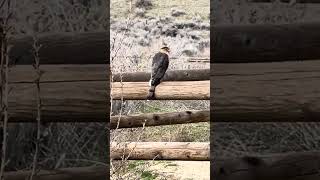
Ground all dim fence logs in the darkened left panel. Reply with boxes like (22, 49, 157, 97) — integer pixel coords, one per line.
(4, 32, 110, 180)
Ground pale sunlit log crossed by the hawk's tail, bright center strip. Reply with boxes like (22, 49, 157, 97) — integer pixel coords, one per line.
(111, 81, 210, 100)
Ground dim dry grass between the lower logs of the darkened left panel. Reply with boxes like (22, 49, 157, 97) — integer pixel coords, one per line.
(7, 123, 107, 170)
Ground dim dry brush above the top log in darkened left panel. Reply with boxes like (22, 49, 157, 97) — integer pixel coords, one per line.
(12, 0, 108, 35)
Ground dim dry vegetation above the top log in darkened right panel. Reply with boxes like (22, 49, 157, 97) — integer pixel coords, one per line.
(212, 0, 320, 24)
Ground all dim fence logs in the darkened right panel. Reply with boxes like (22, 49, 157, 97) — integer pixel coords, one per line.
(214, 3, 320, 180)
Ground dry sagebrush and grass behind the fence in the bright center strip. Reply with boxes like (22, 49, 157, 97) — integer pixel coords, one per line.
(110, 0, 210, 180)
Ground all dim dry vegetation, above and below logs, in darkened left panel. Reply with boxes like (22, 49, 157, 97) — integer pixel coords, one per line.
(0, 0, 107, 171)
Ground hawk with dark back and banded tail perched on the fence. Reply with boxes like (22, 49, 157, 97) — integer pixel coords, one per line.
(147, 46, 170, 100)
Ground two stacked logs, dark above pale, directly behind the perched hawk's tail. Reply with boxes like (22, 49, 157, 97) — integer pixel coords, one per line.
(111, 69, 210, 100)
